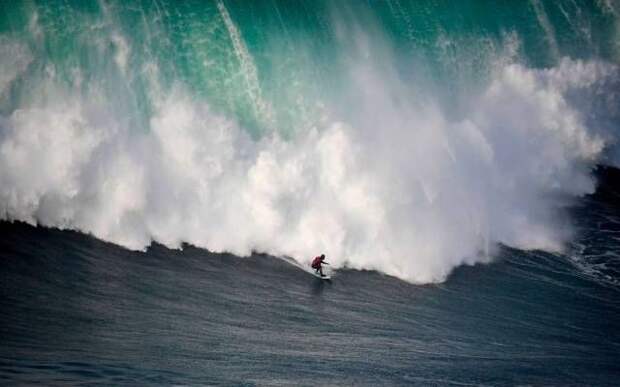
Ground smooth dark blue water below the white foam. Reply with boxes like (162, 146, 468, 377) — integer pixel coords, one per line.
(0, 171, 620, 386)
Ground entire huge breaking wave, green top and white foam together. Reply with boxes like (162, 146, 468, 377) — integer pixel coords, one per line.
(0, 1, 620, 283)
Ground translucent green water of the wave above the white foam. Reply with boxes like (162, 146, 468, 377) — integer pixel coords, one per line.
(0, 0, 620, 136)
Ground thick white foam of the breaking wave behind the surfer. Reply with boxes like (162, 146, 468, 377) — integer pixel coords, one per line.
(0, 31, 618, 283)
